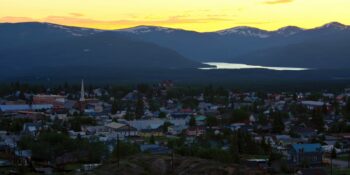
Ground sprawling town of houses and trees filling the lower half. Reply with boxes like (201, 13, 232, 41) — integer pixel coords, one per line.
(0, 80, 350, 175)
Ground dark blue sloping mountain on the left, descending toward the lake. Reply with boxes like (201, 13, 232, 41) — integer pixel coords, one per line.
(0, 23, 201, 78)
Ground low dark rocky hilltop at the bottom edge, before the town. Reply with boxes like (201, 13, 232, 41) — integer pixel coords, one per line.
(94, 155, 264, 175)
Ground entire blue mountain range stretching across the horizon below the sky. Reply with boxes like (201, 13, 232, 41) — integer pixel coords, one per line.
(0, 22, 350, 81)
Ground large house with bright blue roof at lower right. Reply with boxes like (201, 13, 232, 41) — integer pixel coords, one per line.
(289, 143, 323, 166)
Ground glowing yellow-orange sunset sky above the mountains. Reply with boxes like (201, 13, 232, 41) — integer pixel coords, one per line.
(0, 0, 350, 32)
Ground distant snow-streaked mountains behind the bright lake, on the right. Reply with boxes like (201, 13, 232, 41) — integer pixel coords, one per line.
(117, 22, 350, 68)
